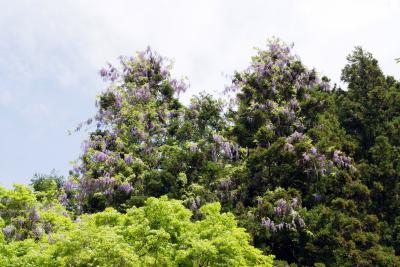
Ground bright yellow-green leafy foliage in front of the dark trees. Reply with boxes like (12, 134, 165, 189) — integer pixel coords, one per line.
(0, 186, 272, 266)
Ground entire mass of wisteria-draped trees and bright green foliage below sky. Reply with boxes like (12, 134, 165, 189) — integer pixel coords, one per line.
(0, 39, 400, 266)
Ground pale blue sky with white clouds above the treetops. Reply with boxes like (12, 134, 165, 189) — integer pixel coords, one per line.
(0, 0, 400, 187)
